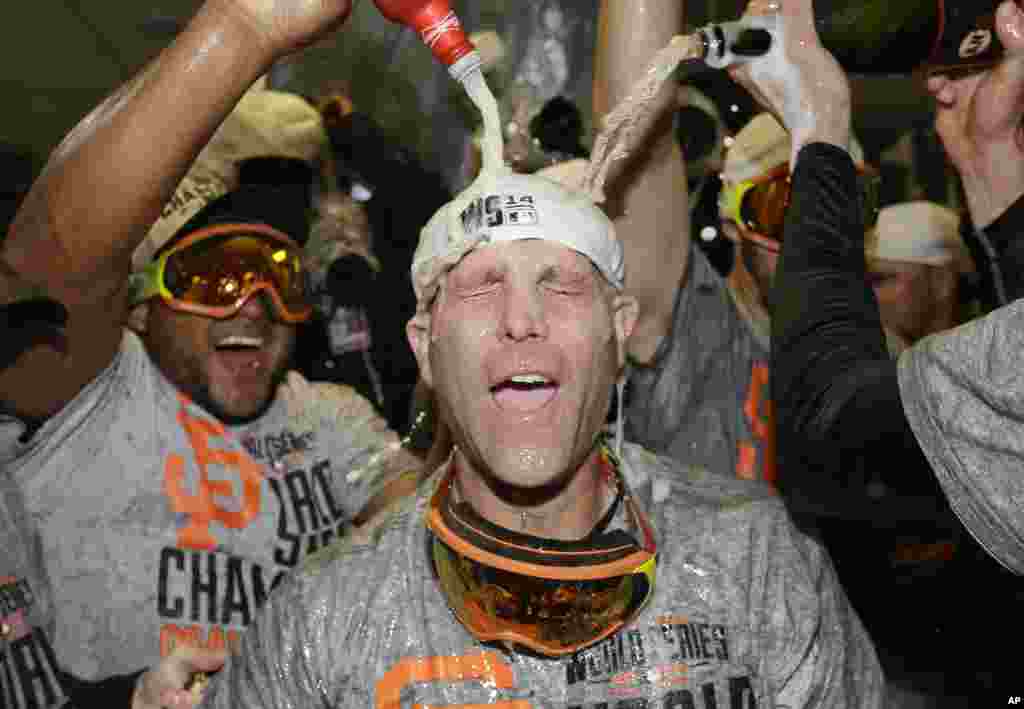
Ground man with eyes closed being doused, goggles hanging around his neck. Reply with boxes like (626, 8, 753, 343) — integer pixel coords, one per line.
(197, 8, 882, 709)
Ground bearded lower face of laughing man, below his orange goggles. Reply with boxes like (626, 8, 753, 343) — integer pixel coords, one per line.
(143, 293, 295, 423)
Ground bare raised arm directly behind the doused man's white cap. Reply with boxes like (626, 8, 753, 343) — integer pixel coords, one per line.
(594, 0, 690, 362)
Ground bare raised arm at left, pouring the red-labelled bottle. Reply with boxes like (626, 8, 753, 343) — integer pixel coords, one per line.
(0, 0, 350, 417)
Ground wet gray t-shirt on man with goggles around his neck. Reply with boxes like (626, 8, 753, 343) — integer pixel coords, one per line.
(201, 445, 883, 709)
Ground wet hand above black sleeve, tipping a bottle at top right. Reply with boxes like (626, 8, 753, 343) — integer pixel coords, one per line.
(729, 0, 851, 162)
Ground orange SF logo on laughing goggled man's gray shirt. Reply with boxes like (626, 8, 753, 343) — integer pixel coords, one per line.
(164, 394, 263, 549)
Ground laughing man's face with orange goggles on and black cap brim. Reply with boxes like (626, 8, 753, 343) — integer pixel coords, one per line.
(128, 184, 312, 422)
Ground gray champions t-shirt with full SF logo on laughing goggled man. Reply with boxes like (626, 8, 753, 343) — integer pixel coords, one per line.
(0, 331, 397, 679)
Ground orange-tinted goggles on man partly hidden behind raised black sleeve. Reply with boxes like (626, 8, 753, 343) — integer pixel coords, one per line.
(719, 164, 881, 242)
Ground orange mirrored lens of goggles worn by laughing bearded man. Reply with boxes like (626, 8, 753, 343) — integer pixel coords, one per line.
(164, 234, 308, 314)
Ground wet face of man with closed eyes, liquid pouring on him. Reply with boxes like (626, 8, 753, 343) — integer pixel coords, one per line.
(409, 240, 636, 488)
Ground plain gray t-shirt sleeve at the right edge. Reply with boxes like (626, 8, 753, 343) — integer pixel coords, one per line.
(899, 300, 1024, 574)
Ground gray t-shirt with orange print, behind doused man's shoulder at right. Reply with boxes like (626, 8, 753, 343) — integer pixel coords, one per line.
(626, 246, 775, 483)
